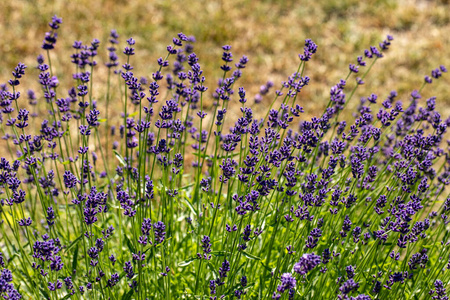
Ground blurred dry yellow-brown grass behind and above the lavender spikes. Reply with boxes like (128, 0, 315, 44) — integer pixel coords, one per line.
(0, 0, 450, 117)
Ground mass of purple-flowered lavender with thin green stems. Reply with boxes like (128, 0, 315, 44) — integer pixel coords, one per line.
(0, 16, 450, 300)
